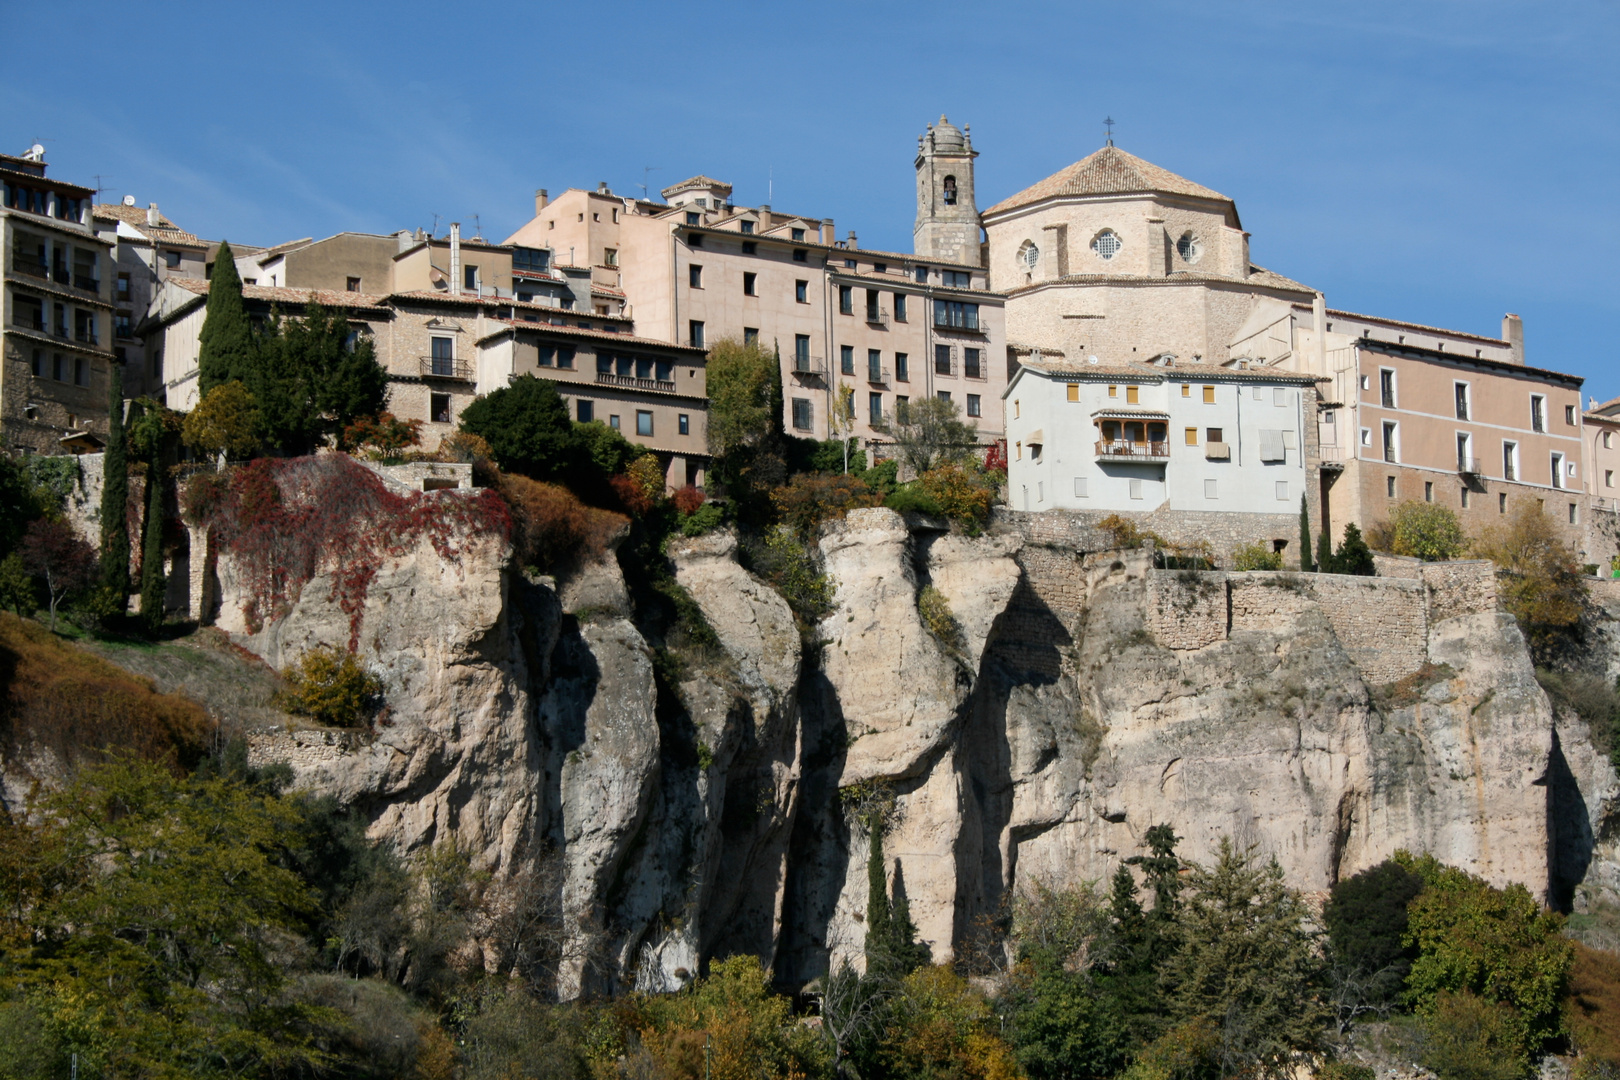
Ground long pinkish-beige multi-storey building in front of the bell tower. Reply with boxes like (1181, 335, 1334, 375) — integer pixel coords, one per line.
(507, 139, 1008, 445)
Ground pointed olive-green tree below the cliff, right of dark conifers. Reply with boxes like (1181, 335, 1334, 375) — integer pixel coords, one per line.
(1165, 837, 1330, 1075)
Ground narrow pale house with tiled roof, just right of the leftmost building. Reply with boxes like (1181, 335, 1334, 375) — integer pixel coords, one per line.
(94, 196, 209, 400)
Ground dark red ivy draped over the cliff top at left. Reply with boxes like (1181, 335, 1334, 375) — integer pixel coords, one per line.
(185, 453, 512, 651)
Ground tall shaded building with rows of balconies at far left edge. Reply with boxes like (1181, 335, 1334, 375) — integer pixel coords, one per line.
(0, 144, 117, 453)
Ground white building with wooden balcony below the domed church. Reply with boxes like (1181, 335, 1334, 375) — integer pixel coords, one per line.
(1006, 353, 1315, 524)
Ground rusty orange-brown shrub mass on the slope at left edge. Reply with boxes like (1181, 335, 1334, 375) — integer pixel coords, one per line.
(0, 615, 214, 769)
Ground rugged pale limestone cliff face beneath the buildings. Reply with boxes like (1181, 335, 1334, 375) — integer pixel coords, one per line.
(220, 510, 1620, 993)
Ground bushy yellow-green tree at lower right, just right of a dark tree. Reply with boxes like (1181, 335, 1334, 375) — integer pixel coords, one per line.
(1396, 853, 1575, 1061)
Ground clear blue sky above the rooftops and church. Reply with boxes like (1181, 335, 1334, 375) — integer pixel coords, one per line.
(15, 0, 1620, 400)
